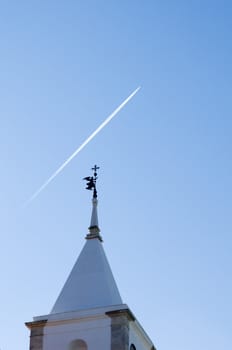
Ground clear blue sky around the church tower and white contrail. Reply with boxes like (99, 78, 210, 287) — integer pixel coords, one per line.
(0, 0, 232, 350)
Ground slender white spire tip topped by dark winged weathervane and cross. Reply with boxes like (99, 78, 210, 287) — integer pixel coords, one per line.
(83, 165, 102, 241)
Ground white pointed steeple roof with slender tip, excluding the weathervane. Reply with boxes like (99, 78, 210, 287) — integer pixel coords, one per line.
(51, 168, 122, 314)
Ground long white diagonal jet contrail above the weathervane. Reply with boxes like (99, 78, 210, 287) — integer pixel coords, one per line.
(26, 86, 140, 205)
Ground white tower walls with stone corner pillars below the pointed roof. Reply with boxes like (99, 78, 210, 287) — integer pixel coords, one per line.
(26, 304, 155, 350)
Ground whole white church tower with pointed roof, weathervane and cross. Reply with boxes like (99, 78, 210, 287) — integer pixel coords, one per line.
(26, 165, 155, 350)
